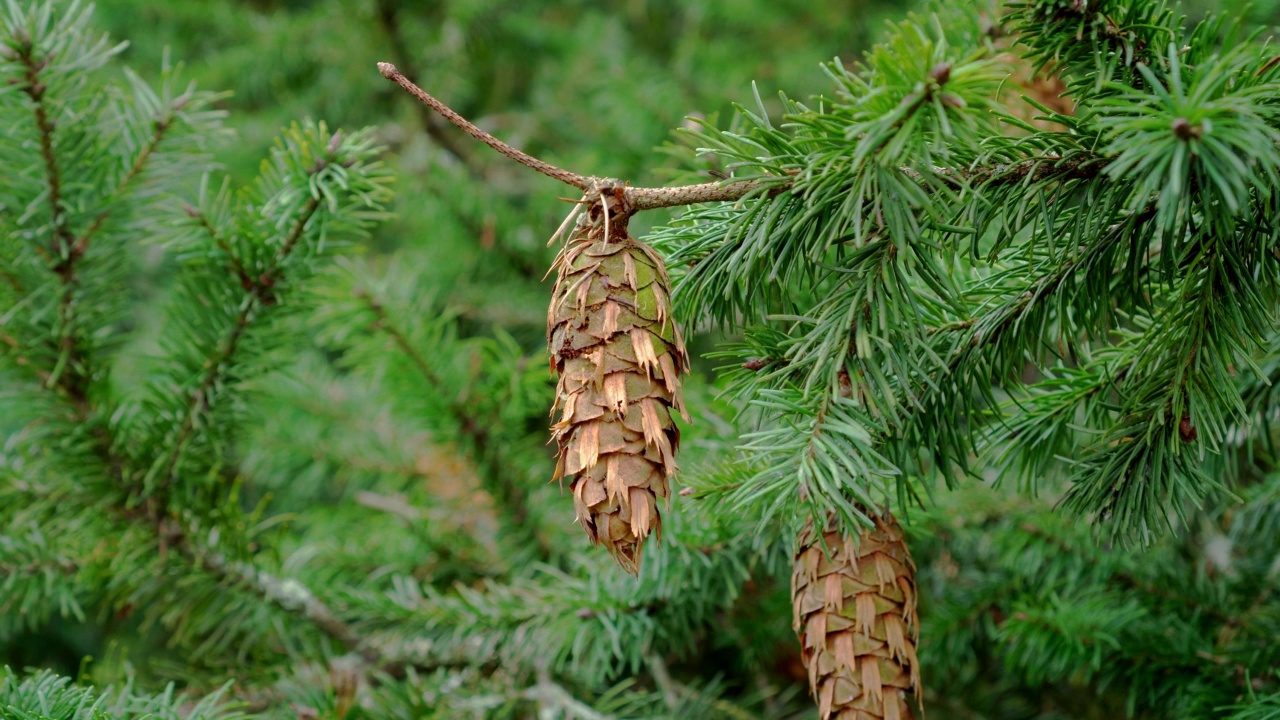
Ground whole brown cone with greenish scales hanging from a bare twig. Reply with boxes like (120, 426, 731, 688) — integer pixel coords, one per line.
(547, 181, 689, 573)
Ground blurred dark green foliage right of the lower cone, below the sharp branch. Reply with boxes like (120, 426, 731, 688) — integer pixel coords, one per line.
(915, 479, 1280, 717)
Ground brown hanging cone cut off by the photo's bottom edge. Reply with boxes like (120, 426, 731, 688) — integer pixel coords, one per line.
(791, 514, 920, 720)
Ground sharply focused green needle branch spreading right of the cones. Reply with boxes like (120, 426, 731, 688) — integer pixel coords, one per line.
(655, 1, 1280, 541)
